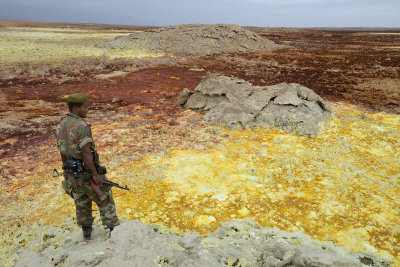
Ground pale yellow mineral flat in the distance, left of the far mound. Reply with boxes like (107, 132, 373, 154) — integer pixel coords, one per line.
(0, 27, 163, 69)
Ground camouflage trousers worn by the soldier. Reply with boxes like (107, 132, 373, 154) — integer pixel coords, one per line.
(63, 175, 119, 228)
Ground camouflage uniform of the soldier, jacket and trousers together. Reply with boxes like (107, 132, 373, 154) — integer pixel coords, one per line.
(56, 114, 119, 228)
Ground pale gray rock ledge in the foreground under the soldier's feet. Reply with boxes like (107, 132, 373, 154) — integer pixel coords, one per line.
(16, 219, 390, 267)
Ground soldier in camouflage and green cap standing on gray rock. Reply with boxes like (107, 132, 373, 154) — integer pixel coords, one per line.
(56, 94, 119, 240)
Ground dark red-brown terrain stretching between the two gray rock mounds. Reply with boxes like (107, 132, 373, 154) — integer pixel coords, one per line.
(0, 25, 400, 160)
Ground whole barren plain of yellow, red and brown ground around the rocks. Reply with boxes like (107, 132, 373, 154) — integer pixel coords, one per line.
(0, 21, 400, 266)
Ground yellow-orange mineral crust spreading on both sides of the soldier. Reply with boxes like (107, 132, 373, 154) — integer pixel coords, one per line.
(0, 103, 400, 265)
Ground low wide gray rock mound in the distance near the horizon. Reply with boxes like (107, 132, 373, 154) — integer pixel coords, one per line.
(98, 24, 284, 55)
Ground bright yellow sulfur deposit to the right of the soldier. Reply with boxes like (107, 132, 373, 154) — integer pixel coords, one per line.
(114, 104, 400, 264)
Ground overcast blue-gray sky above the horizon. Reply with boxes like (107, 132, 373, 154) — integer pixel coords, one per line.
(0, 0, 400, 27)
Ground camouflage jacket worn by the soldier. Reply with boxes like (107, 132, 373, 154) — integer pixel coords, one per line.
(56, 113, 95, 159)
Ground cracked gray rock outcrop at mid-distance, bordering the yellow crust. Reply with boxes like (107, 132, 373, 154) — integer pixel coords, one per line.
(178, 74, 332, 137)
